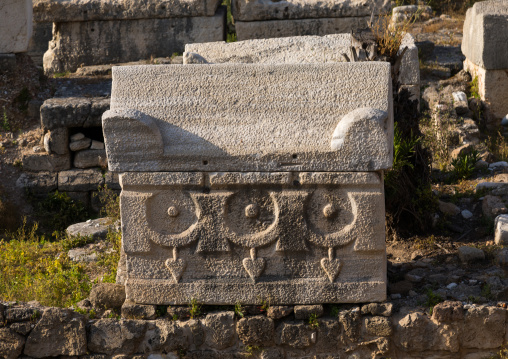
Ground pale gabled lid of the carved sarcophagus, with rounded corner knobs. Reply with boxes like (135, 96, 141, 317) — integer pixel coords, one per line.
(103, 62, 393, 172)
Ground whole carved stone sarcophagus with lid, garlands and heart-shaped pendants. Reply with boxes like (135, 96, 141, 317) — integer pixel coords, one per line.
(103, 62, 393, 304)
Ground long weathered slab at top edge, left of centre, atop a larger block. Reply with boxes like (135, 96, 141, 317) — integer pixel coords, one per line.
(33, 0, 220, 23)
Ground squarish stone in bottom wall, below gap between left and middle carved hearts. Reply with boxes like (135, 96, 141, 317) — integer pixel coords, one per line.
(203, 312, 236, 349)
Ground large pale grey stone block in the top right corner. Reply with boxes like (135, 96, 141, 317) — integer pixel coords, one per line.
(462, 0, 508, 70)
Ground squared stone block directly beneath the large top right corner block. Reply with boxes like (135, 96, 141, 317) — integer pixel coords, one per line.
(464, 59, 508, 119)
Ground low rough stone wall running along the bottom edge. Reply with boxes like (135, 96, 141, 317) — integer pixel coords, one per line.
(0, 300, 507, 359)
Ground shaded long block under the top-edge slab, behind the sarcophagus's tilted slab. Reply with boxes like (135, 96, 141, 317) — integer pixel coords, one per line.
(235, 15, 377, 41)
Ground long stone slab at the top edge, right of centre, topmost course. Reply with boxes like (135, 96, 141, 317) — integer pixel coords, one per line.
(232, 0, 392, 21)
